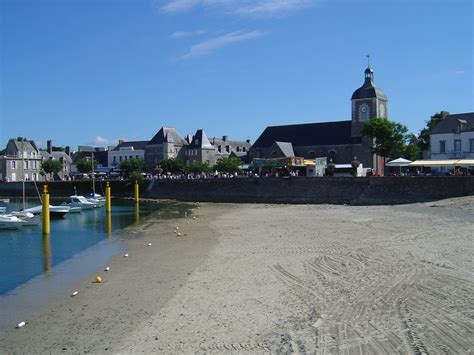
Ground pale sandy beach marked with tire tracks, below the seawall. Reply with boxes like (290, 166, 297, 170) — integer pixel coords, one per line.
(0, 197, 474, 354)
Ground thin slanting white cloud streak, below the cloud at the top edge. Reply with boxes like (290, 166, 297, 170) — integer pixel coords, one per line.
(182, 31, 265, 59)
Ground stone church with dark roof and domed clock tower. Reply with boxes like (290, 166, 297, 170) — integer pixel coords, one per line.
(249, 66, 388, 171)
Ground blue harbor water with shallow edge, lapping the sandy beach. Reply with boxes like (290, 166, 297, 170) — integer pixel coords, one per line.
(0, 199, 189, 328)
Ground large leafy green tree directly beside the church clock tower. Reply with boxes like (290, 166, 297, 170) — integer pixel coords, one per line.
(362, 118, 408, 158)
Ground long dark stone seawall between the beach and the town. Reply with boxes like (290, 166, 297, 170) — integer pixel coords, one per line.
(0, 176, 474, 205)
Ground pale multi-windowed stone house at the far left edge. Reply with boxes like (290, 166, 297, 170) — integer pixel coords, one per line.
(0, 139, 44, 181)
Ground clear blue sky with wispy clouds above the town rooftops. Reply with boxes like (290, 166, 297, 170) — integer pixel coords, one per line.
(0, 0, 474, 148)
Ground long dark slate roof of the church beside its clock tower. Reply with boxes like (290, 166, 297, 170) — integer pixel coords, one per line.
(252, 121, 361, 148)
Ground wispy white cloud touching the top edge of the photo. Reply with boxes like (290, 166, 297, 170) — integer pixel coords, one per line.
(161, 0, 318, 15)
